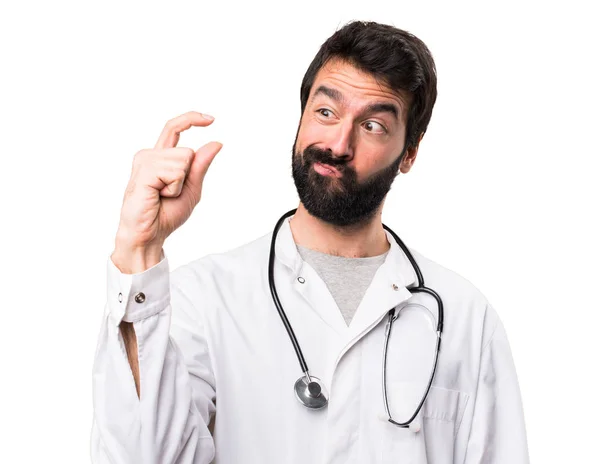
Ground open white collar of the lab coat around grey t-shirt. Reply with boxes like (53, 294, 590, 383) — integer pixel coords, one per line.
(275, 217, 417, 339)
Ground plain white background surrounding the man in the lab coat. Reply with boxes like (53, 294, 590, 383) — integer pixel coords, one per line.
(0, 0, 600, 463)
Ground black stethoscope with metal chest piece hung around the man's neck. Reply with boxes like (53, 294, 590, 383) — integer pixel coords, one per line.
(269, 209, 444, 431)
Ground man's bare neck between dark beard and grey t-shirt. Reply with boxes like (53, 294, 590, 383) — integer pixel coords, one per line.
(290, 203, 390, 258)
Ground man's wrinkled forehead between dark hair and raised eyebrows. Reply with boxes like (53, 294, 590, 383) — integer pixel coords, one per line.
(310, 59, 409, 113)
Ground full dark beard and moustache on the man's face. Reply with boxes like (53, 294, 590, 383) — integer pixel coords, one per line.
(292, 142, 406, 227)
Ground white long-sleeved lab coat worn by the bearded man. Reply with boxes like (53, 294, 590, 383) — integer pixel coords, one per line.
(91, 218, 529, 464)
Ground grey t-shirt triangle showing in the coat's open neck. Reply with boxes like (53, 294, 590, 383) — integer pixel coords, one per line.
(296, 244, 388, 325)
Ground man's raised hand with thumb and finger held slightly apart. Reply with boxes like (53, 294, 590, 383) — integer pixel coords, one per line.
(115, 111, 223, 256)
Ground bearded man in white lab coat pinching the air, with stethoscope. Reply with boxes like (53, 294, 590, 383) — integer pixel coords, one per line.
(91, 21, 528, 464)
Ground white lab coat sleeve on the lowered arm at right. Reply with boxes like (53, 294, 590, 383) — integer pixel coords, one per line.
(464, 306, 529, 464)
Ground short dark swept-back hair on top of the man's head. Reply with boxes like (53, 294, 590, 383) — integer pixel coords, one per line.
(300, 21, 437, 148)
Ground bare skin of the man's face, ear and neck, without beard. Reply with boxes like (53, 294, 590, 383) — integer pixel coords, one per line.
(290, 59, 424, 258)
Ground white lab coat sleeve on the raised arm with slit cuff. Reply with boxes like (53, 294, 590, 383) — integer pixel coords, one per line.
(91, 251, 215, 464)
